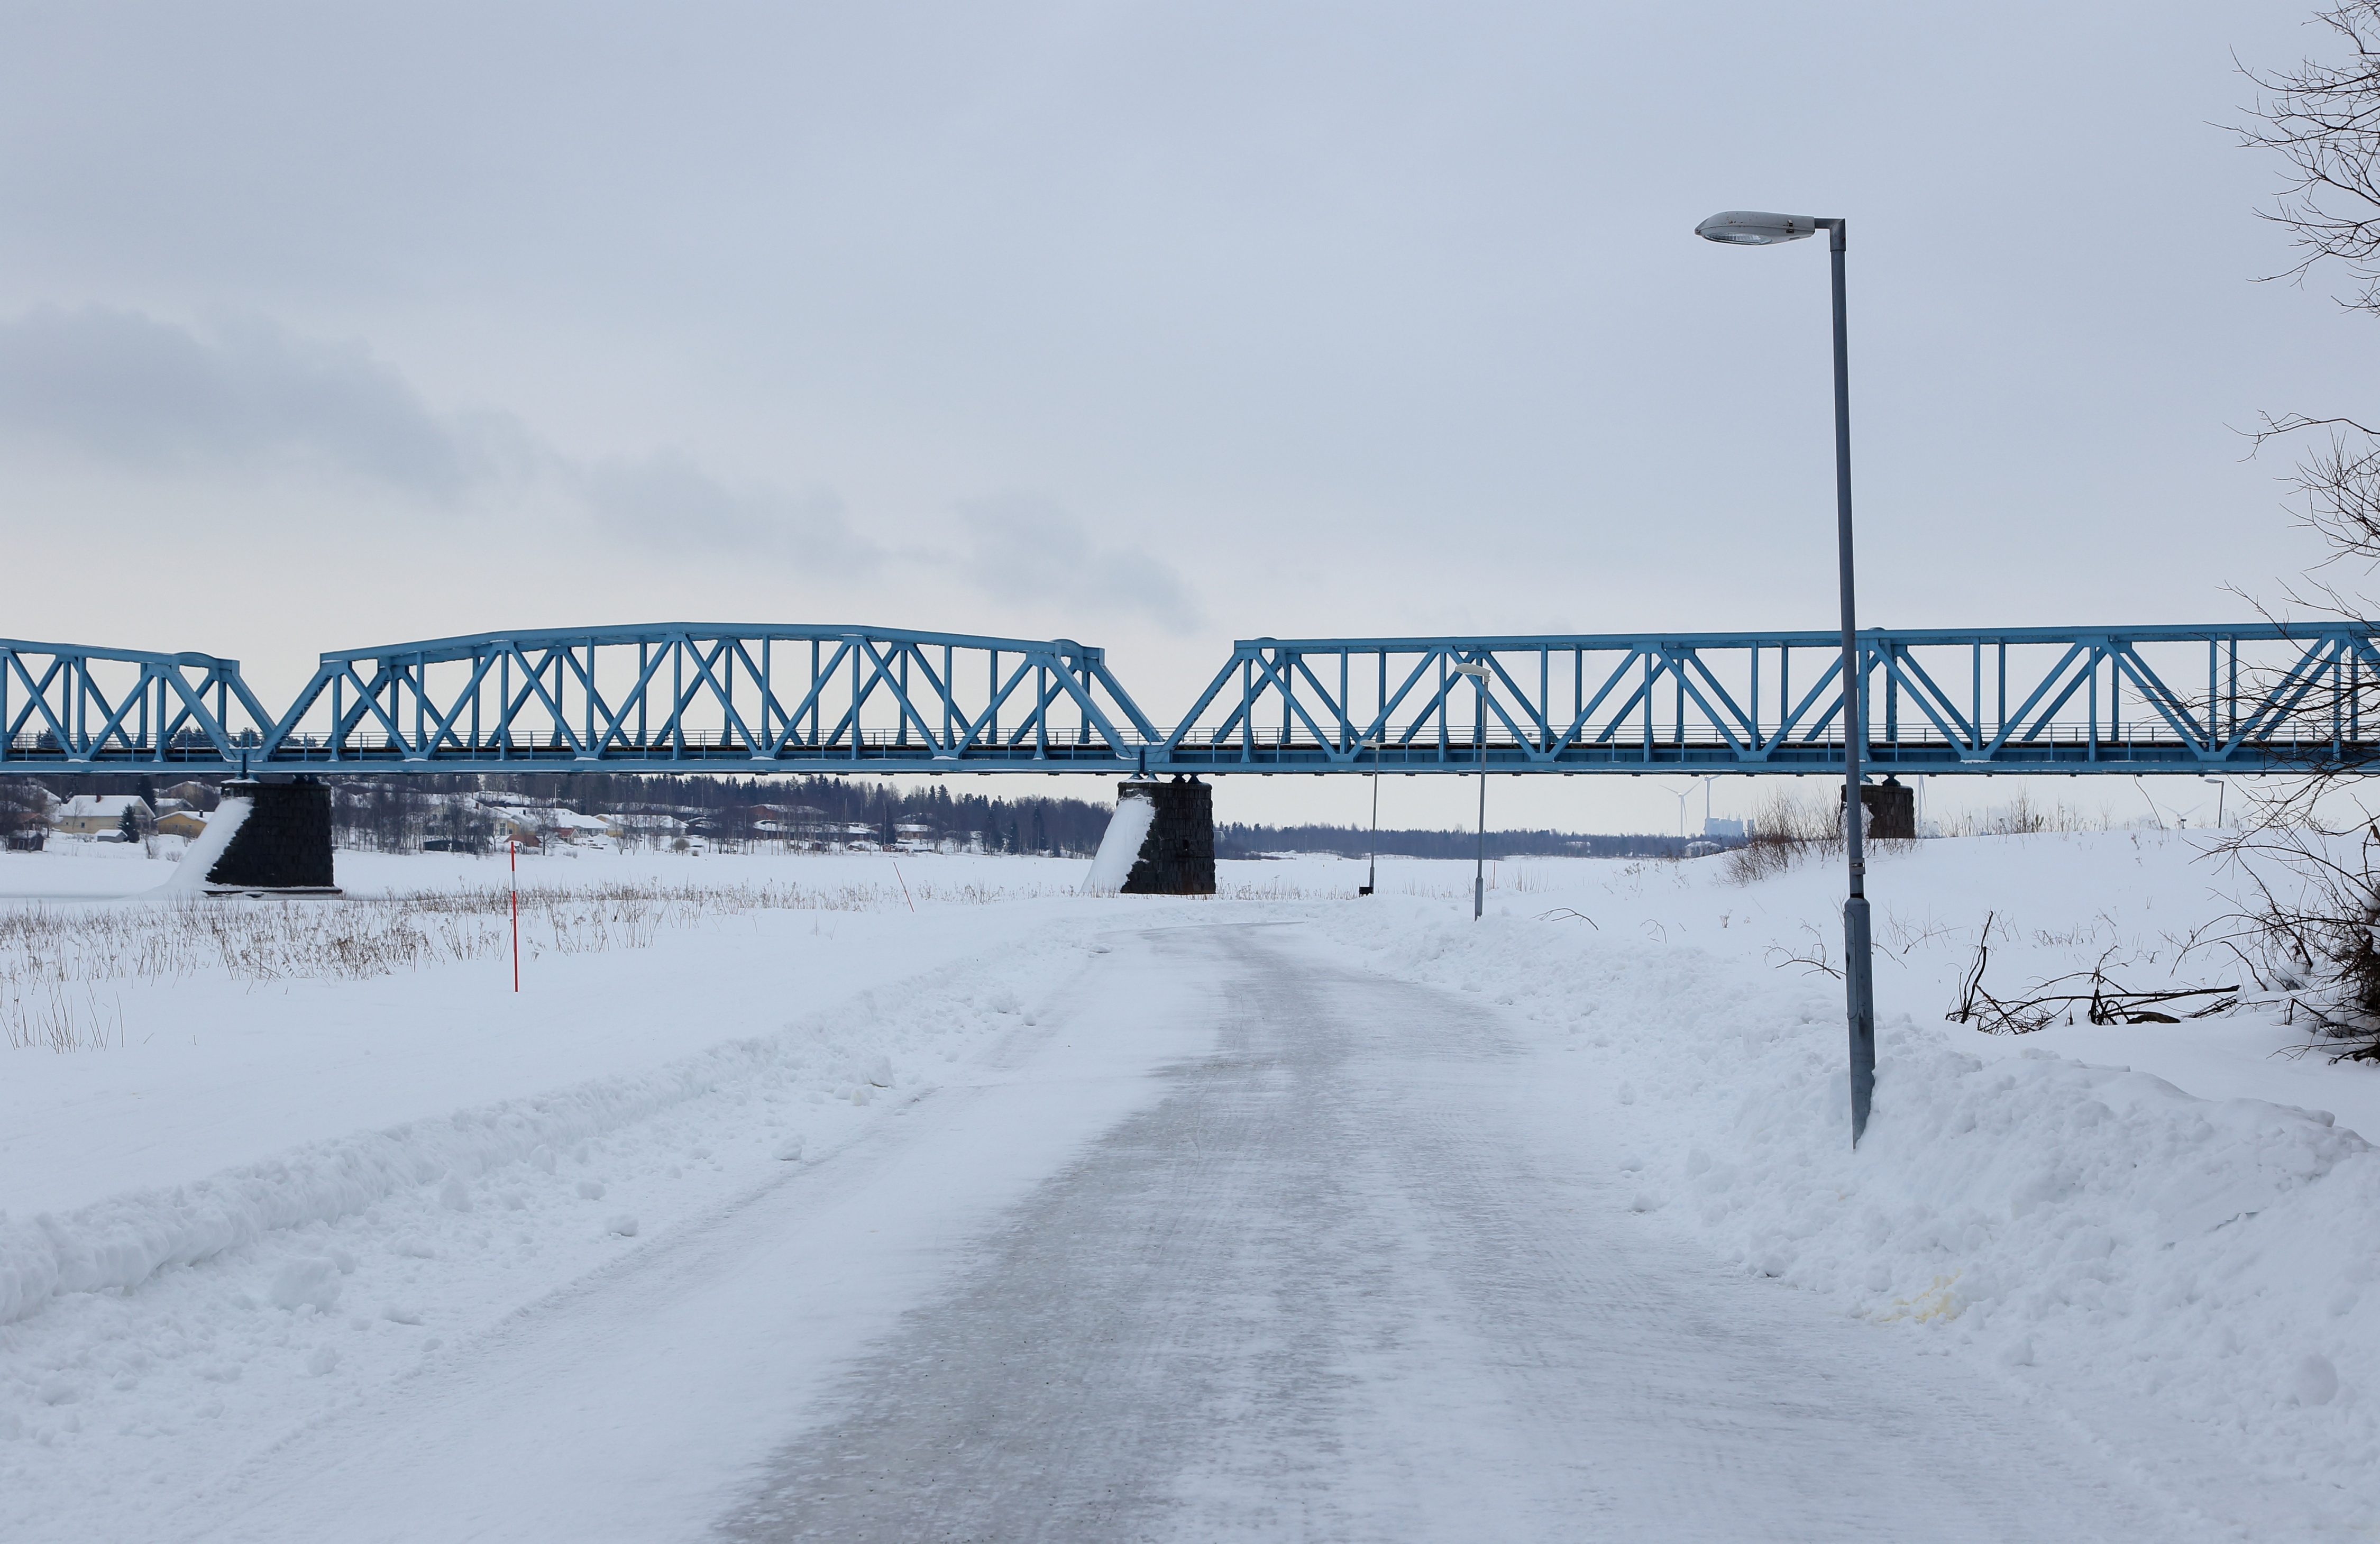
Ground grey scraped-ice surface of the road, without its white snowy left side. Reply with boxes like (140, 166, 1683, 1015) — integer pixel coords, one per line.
(721, 926, 2175, 1542)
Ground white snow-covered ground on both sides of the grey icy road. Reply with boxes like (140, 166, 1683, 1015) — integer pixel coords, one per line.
(0, 833, 2380, 1539)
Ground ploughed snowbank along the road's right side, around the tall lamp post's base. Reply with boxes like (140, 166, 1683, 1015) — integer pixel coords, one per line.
(1333, 913, 2380, 1513)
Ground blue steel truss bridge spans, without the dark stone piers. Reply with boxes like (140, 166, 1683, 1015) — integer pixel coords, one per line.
(0, 623, 2380, 775)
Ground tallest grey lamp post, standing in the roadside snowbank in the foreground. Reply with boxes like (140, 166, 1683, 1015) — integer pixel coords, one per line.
(1695, 209, 1875, 1147)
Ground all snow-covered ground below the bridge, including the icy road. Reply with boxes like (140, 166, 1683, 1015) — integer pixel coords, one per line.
(0, 833, 2380, 1544)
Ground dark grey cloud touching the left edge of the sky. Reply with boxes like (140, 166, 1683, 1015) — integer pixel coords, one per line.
(0, 307, 507, 497)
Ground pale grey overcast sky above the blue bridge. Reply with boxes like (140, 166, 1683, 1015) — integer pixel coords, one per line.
(0, 0, 2370, 826)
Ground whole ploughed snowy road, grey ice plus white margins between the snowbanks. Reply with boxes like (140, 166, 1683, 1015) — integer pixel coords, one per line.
(181, 926, 2197, 1542)
